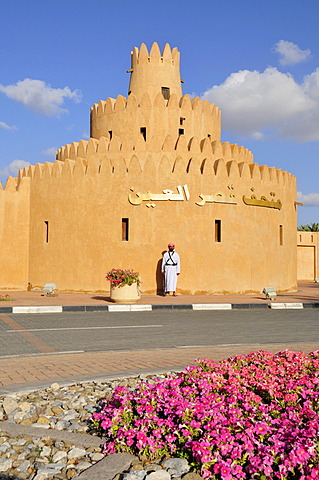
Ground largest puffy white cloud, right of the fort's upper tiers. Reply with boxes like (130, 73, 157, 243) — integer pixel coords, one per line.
(202, 67, 319, 142)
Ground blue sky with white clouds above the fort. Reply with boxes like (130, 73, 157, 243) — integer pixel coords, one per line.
(0, 0, 319, 224)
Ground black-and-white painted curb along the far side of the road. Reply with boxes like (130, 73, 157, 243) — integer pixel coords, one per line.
(0, 302, 319, 314)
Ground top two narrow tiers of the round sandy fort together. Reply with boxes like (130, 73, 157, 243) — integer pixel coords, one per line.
(90, 42, 221, 143)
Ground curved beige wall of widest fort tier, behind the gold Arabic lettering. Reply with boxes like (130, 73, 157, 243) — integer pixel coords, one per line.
(21, 154, 296, 294)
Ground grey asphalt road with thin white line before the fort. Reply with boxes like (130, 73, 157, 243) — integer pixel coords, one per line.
(0, 309, 319, 357)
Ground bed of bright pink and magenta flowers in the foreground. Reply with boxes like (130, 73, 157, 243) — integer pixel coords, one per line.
(91, 351, 319, 480)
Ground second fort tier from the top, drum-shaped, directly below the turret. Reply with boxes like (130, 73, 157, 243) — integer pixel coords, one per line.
(91, 92, 221, 146)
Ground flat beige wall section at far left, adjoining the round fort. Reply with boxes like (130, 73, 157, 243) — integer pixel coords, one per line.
(0, 177, 30, 290)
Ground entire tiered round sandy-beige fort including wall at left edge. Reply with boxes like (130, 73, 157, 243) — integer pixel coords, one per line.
(0, 43, 297, 294)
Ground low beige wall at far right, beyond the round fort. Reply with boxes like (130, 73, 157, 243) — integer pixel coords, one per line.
(297, 232, 319, 281)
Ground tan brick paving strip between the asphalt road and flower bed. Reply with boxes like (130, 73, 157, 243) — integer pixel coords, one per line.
(0, 343, 318, 393)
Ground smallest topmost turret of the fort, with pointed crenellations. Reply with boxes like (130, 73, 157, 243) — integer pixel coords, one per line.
(128, 42, 182, 100)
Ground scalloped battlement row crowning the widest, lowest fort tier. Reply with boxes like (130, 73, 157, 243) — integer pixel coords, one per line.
(13, 149, 296, 192)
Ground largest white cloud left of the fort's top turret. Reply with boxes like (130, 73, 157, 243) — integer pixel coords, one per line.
(0, 78, 81, 117)
